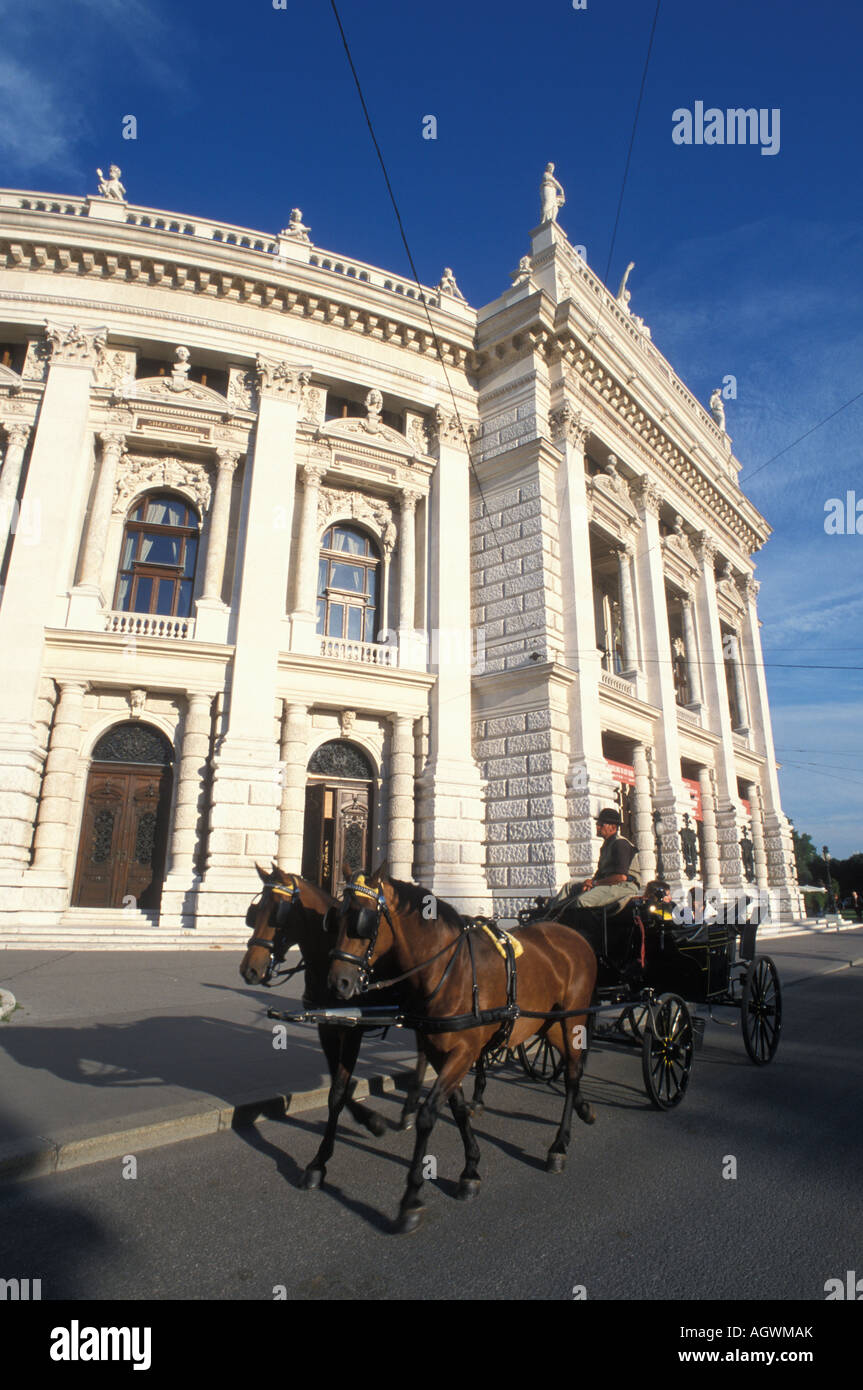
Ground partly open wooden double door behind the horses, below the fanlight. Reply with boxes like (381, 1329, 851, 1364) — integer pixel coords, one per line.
(303, 781, 371, 897)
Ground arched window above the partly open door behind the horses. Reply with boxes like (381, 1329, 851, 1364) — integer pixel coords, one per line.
(315, 525, 381, 642)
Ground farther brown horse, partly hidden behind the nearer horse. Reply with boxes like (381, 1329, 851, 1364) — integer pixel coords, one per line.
(239, 865, 428, 1187)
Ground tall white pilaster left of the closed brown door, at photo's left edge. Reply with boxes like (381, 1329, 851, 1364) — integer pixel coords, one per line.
(0, 325, 107, 872)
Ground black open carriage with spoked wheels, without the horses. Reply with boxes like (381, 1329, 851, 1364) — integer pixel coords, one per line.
(517, 898, 782, 1109)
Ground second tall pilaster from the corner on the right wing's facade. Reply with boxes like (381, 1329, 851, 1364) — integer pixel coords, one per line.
(634, 474, 691, 888)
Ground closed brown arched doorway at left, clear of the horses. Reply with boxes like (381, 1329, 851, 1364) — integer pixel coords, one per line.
(72, 720, 174, 908)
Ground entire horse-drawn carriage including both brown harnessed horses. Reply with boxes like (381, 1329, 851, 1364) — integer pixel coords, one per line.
(240, 866, 781, 1232)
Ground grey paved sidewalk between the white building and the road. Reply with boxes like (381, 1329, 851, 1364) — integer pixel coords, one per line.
(0, 927, 863, 1182)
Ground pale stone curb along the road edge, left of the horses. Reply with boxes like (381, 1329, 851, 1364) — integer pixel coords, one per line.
(0, 1072, 411, 1184)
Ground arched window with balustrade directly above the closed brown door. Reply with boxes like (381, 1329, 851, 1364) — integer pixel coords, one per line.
(114, 493, 200, 617)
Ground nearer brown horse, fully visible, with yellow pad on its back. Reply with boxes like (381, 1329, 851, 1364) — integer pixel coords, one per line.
(329, 865, 596, 1232)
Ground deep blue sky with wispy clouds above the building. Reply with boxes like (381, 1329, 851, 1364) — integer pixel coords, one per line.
(0, 0, 863, 855)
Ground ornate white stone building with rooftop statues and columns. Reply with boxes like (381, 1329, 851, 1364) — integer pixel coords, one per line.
(0, 185, 798, 940)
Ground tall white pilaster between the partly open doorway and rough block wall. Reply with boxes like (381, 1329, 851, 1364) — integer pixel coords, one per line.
(417, 407, 491, 912)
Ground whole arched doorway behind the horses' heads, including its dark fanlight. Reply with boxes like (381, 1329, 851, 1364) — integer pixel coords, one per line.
(303, 738, 374, 897)
